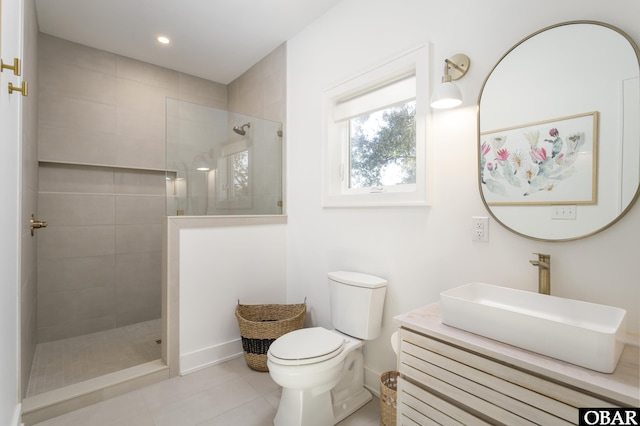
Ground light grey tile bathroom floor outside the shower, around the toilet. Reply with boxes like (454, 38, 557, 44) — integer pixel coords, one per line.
(37, 357, 380, 426)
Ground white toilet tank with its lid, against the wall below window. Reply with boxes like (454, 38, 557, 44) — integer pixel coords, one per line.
(329, 271, 387, 340)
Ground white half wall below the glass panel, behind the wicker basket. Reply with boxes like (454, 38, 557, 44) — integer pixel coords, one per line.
(172, 220, 284, 374)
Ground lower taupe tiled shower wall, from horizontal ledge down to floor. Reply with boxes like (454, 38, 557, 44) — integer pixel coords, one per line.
(38, 163, 165, 342)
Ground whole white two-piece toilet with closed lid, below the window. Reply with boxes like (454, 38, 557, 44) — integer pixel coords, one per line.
(267, 271, 387, 426)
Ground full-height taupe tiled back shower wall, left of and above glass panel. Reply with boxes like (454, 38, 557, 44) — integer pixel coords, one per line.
(36, 34, 227, 342)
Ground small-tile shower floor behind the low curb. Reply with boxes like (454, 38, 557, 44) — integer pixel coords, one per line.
(27, 319, 161, 397)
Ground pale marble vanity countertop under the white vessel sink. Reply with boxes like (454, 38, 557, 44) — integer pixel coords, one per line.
(394, 303, 640, 407)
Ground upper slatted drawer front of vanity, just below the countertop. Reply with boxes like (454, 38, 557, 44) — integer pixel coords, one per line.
(400, 329, 614, 425)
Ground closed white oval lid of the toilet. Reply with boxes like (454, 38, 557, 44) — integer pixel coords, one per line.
(269, 327, 344, 365)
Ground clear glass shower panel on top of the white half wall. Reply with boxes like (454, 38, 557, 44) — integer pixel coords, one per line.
(167, 98, 283, 216)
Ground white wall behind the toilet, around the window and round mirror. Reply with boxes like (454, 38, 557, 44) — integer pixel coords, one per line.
(287, 0, 640, 387)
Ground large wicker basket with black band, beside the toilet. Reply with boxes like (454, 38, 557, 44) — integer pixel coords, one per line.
(236, 301, 307, 371)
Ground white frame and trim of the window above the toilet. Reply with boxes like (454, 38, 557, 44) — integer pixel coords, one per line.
(322, 45, 429, 207)
